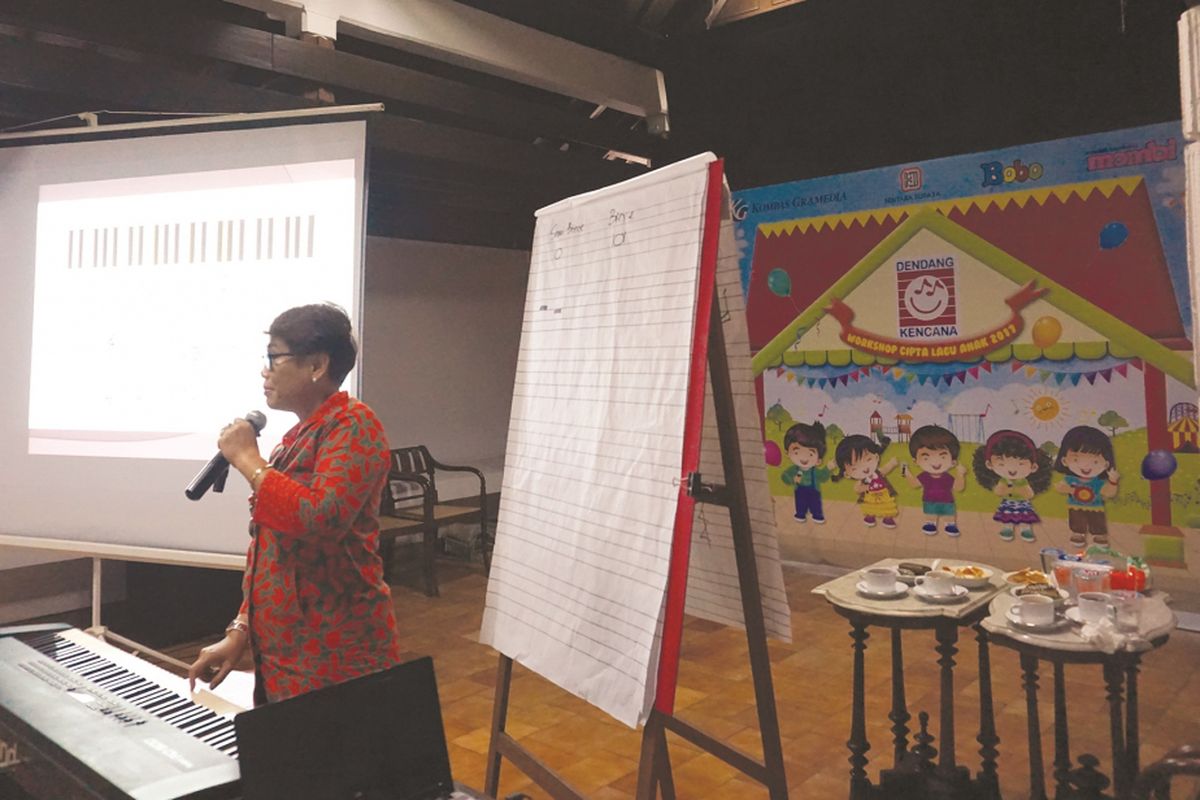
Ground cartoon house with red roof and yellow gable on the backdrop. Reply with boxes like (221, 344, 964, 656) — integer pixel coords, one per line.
(748, 176, 1196, 566)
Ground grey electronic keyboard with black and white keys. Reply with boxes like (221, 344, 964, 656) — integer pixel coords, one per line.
(0, 628, 240, 800)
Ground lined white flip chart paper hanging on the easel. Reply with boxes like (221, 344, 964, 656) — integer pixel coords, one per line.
(480, 155, 790, 726)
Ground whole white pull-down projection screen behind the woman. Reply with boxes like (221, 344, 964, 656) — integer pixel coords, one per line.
(0, 107, 366, 554)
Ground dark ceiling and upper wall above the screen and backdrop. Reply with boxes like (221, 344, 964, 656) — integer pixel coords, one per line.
(0, 0, 1188, 248)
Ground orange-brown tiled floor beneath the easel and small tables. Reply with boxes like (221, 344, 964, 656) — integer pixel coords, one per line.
(169, 563, 1200, 800)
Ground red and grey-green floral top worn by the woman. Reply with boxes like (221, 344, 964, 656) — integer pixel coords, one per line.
(241, 392, 400, 702)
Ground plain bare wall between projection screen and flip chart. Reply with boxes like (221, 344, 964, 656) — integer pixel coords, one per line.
(362, 237, 529, 497)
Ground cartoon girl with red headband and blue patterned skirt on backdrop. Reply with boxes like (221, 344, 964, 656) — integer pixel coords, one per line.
(974, 431, 1054, 542)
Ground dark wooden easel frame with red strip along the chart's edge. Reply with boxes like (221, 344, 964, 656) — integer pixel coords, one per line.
(485, 161, 787, 800)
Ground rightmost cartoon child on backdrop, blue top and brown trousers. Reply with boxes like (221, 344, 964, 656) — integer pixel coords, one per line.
(1054, 425, 1121, 547)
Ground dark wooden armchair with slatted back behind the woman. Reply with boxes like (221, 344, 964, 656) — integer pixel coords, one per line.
(379, 445, 492, 597)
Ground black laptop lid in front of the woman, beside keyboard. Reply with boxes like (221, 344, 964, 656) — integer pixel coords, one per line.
(234, 657, 472, 800)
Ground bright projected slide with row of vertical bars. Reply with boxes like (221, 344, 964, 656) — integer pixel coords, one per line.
(29, 160, 360, 459)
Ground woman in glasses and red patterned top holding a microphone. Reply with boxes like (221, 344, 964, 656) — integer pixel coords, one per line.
(188, 305, 400, 704)
